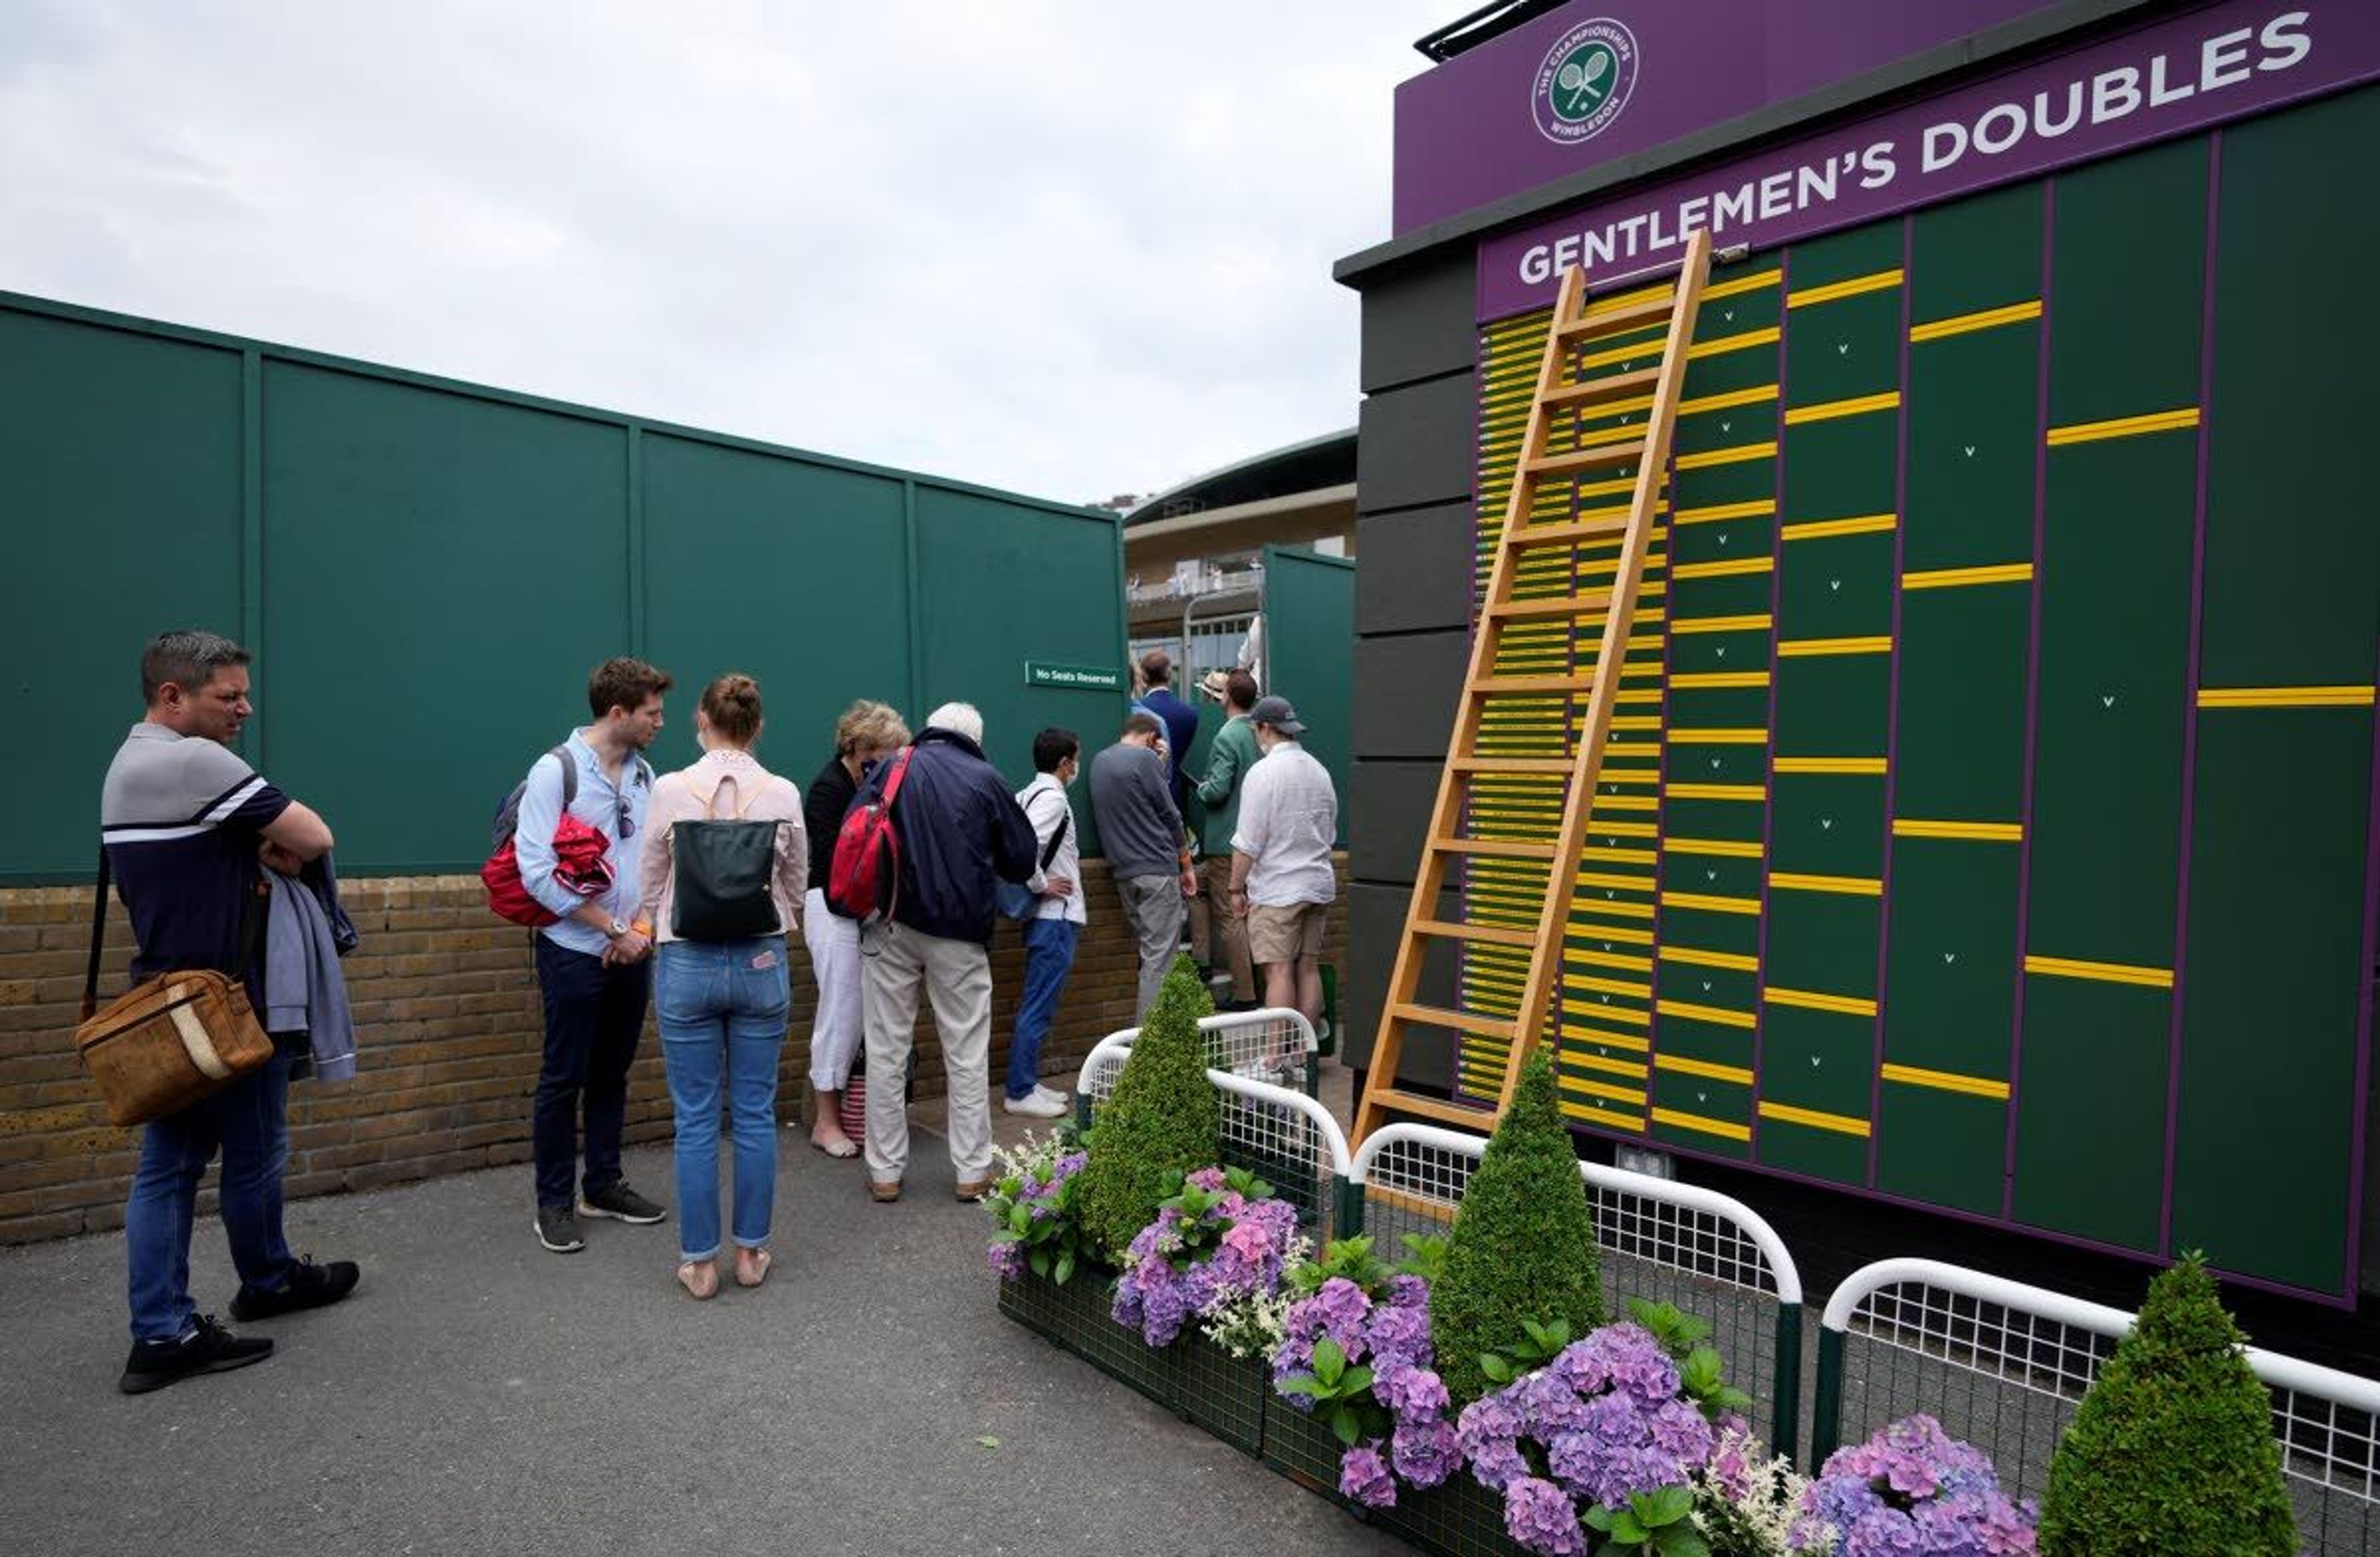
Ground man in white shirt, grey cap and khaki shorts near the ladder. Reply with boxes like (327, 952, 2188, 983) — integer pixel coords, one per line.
(1230, 697, 1338, 1026)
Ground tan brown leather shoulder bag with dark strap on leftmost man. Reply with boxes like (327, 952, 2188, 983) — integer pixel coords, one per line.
(74, 845, 274, 1126)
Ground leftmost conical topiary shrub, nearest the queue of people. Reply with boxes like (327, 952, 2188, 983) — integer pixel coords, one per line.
(1076, 957, 1221, 1264)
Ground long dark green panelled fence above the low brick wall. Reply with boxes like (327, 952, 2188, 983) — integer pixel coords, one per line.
(0, 293, 1123, 883)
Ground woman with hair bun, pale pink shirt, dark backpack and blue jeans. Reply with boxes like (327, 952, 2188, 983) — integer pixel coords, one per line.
(638, 676, 809, 1297)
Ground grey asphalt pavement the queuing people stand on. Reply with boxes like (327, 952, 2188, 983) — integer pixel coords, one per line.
(0, 1085, 1404, 1557)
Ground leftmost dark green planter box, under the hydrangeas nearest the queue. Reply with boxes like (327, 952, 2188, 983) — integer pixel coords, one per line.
(1000, 1269, 1271, 1455)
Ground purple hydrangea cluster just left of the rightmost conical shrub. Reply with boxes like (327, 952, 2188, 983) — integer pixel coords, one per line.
(1794, 1414, 2035, 1557)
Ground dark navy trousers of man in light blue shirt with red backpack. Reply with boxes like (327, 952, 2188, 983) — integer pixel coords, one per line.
(531, 936, 652, 1205)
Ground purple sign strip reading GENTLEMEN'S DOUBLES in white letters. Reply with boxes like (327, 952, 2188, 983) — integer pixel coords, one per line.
(1478, 0, 2380, 319)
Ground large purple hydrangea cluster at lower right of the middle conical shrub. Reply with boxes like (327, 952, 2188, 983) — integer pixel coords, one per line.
(1457, 1324, 1718, 1557)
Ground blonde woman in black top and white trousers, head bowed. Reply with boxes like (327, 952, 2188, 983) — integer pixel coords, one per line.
(802, 700, 909, 1157)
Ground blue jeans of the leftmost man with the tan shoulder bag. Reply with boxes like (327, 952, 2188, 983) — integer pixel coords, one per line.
(124, 1045, 295, 1340)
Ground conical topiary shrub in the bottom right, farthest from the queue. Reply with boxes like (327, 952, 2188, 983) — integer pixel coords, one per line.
(2040, 1255, 2297, 1557)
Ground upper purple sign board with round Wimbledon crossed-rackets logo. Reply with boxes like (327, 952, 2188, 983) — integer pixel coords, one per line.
(1392, 0, 2084, 233)
